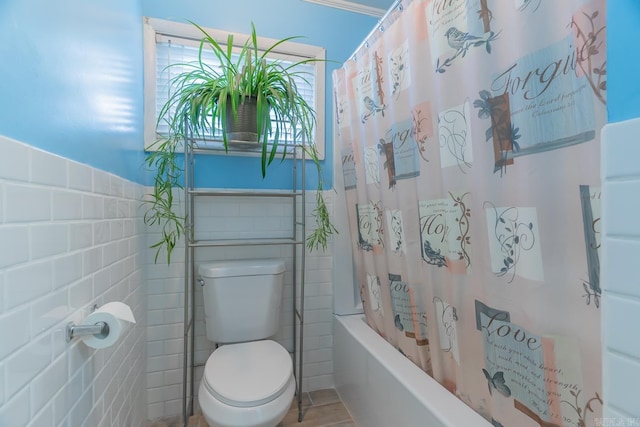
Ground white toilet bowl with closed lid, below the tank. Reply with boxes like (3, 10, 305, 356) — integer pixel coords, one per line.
(198, 340, 296, 427)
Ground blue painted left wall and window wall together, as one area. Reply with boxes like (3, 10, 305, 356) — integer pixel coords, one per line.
(0, 0, 377, 188)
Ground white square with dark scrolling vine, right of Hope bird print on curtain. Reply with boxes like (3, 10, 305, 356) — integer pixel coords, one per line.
(484, 202, 535, 283)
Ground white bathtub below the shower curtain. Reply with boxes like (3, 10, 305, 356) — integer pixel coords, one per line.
(333, 314, 492, 427)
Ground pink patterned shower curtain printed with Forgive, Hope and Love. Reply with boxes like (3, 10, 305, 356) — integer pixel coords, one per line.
(333, 0, 606, 427)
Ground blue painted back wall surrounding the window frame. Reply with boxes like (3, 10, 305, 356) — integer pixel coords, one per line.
(142, 0, 378, 189)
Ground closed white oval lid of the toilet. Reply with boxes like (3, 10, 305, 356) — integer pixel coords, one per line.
(203, 340, 293, 406)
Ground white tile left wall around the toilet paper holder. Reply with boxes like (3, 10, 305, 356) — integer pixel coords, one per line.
(0, 137, 147, 427)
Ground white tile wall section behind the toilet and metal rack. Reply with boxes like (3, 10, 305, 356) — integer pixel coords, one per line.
(147, 192, 333, 420)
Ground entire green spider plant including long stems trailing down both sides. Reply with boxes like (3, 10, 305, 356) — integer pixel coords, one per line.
(144, 22, 337, 263)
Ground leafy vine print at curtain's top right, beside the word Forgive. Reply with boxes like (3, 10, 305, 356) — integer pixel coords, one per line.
(569, 10, 607, 105)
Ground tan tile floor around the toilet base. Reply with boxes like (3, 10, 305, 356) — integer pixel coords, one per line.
(147, 389, 357, 427)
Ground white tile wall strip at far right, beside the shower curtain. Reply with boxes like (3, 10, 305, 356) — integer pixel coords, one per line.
(601, 119, 640, 425)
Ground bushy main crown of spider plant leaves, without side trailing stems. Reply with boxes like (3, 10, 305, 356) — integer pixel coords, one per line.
(159, 22, 320, 176)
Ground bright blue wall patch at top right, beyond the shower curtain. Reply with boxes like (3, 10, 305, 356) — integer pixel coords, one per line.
(607, 0, 640, 122)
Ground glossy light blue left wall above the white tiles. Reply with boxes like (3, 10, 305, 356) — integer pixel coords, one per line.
(0, 0, 144, 181)
